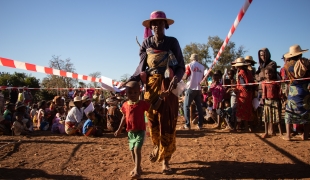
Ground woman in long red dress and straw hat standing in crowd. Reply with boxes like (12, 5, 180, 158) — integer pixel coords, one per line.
(232, 57, 254, 131)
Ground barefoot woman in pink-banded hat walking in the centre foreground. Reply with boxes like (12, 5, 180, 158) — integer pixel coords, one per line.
(129, 11, 185, 174)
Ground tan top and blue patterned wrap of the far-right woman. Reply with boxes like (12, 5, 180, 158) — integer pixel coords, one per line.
(284, 60, 310, 124)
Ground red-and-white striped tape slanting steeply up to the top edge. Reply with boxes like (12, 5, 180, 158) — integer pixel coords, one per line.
(201, 0, 253, 83)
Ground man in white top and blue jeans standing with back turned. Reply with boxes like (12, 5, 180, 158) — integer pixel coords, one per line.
(183, 54, 204, 130)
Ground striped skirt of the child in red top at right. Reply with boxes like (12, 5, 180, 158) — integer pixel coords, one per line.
(262, 99, 281, 123)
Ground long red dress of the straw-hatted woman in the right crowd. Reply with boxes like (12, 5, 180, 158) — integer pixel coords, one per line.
(236, 69, 254, 121)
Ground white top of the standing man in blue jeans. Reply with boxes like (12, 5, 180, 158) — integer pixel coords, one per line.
(185, 61, 205, 90)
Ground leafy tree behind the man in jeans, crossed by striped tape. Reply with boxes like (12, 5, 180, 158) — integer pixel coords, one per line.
(183, 36, 247, 72)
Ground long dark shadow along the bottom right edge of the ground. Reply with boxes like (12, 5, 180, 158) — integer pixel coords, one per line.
(175, 161, 310, 179)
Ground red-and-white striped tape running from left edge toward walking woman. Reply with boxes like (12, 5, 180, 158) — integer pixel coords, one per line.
(0, 57, 121, 88)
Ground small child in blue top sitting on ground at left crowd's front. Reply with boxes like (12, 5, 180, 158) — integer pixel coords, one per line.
(82, 111, 102, 136)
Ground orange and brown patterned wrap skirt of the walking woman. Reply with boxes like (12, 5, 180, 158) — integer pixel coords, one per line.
(144, 74, 178, 162)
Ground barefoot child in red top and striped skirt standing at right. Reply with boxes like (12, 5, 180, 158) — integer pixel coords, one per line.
(261, 68, 282, 138)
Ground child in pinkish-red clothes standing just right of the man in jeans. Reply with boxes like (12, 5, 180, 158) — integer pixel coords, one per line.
(209, 72, 225, 128)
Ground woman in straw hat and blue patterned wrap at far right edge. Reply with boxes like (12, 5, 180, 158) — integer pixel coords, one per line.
(283, 45, 310, 140)
